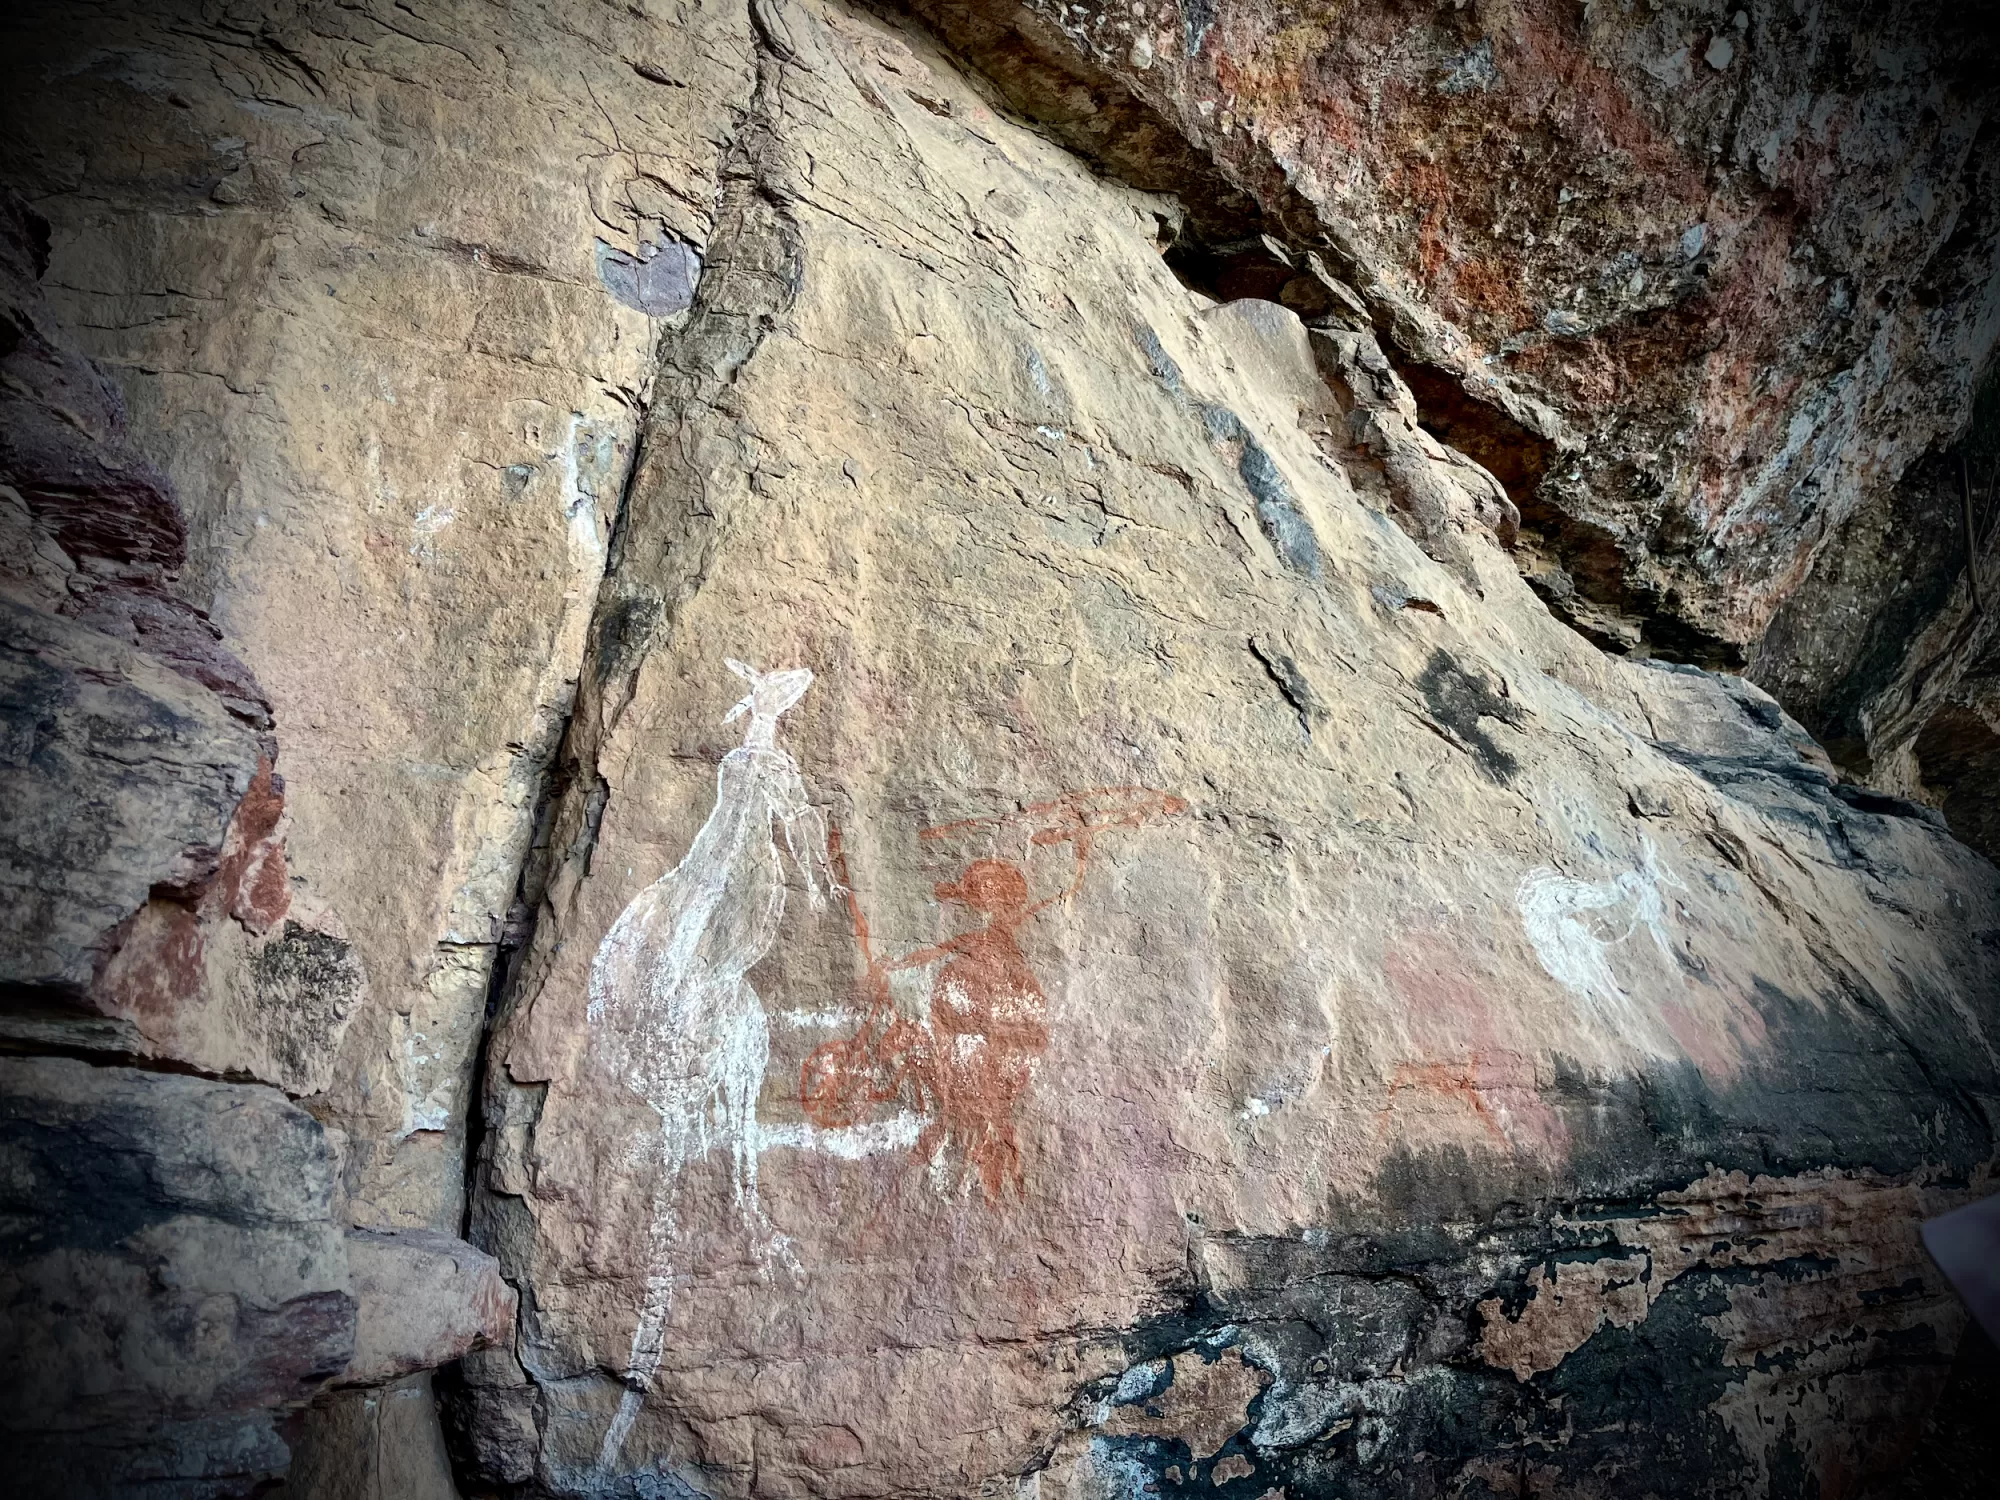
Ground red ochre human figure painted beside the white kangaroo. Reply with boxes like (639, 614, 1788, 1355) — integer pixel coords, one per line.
(800, 788, 1186, 1202)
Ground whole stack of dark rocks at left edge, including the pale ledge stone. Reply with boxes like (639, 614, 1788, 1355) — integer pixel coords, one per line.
(0, 55, 548, 1496)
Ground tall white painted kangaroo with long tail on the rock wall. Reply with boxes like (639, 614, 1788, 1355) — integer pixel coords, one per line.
(588, 660, 838, 1470)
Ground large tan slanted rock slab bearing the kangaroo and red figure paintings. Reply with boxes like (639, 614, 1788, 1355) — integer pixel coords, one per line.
(446, 4, 2000, 1494)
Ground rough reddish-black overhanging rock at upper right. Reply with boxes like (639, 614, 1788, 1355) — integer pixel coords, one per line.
(914, 0, 2000, 848)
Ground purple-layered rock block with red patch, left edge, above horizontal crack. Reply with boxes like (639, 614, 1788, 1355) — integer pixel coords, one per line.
(0, 194, 362, 1092)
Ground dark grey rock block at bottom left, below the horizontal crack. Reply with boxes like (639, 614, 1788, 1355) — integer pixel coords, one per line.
(0, 1058, 356, 1494)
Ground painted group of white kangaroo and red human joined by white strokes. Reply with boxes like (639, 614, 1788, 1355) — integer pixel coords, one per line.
(574, 660, 1186, 1474)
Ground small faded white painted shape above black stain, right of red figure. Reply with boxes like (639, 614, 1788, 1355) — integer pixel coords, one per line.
(1516, 840, 1686, 1036)
